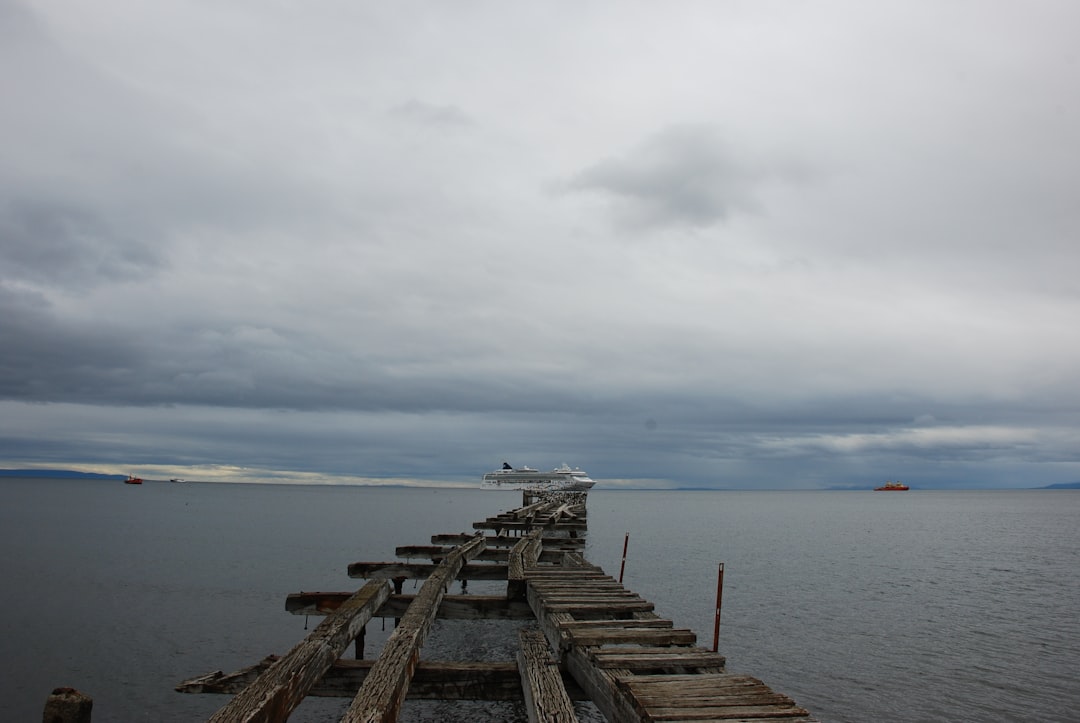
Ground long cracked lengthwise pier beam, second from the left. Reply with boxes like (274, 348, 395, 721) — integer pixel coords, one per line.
(341, 535, 485, 723)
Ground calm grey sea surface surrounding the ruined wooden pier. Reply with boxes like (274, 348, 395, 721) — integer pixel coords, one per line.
(0, 479, 1080, 723)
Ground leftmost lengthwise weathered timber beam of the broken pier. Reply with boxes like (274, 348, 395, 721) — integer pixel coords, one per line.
(210, 580, 390, 723)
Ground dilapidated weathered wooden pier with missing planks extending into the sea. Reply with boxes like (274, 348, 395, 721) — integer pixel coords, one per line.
(176, 493, 815, 723)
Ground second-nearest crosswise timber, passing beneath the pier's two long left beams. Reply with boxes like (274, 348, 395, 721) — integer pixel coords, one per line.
(285, 592, 535, 620)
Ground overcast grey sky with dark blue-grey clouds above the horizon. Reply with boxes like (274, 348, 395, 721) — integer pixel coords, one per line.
(0, 0, 1080, 488)
